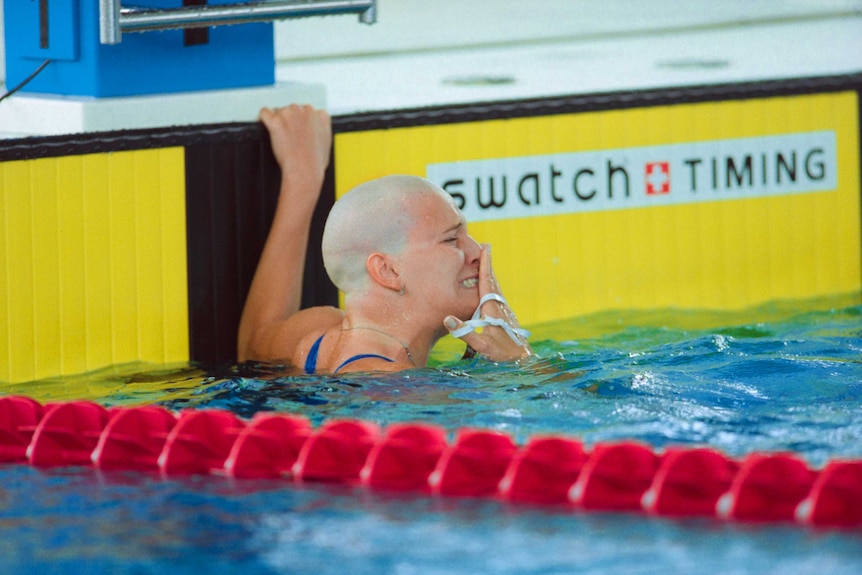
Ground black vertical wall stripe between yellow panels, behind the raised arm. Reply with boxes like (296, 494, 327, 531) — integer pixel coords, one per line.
(186, 138, 338, 365)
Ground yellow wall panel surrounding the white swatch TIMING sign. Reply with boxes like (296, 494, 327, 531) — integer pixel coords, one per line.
(335, 92, 862, 324)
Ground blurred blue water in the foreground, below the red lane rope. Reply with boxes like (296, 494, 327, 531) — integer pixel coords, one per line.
(5, 466, 862, 575)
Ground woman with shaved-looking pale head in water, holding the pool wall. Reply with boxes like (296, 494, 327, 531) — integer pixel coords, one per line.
(238, 105, 532, 373)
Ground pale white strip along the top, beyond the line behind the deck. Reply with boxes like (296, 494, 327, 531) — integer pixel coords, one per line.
(0, 0, 862, 88)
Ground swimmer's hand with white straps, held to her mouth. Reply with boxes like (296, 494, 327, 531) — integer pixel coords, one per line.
(443, 245, 533, 361)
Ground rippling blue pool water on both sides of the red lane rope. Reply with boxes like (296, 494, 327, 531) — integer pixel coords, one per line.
(0, 295, 862, 574)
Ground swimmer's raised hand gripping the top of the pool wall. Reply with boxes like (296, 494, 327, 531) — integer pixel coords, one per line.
(259, 104, 332, 209)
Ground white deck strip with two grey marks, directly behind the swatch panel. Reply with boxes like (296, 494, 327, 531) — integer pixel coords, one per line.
(276, 14, 862, 114)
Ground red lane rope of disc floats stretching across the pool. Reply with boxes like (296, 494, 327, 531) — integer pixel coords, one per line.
(0, 396, 862, 529)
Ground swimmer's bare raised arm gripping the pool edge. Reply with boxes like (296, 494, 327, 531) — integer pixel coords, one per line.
(237, 105, 341, 361)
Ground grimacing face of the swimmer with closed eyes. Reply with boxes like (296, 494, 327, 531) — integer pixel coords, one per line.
(402, 191, 481, 324)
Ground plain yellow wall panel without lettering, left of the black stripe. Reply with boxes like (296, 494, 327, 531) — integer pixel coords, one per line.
(0, 148, 189, 382)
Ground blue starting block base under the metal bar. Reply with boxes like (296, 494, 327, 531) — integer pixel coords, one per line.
(3, 0, 275, 98)
